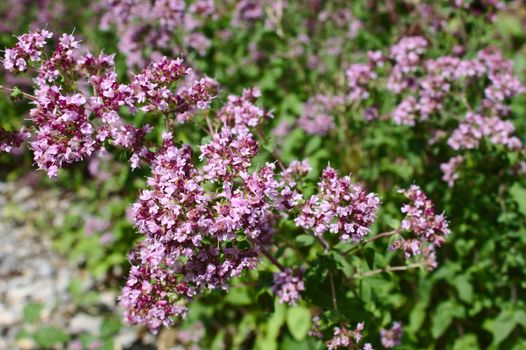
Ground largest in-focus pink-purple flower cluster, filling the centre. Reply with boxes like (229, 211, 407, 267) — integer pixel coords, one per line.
(122, 83, 286, 329)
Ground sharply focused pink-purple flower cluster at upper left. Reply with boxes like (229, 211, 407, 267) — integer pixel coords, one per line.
(3, 31, 217, 176)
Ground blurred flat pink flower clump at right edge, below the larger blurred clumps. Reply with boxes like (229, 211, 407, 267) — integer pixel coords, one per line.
(447, 112, 522, 150)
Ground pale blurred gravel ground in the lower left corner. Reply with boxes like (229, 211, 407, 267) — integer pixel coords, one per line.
(0, 182, 156, 349)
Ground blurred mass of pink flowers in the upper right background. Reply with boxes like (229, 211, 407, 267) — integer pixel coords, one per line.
(336, 36, 526, 186)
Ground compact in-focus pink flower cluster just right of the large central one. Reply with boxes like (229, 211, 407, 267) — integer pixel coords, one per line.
(295, 167, 380, 241)
